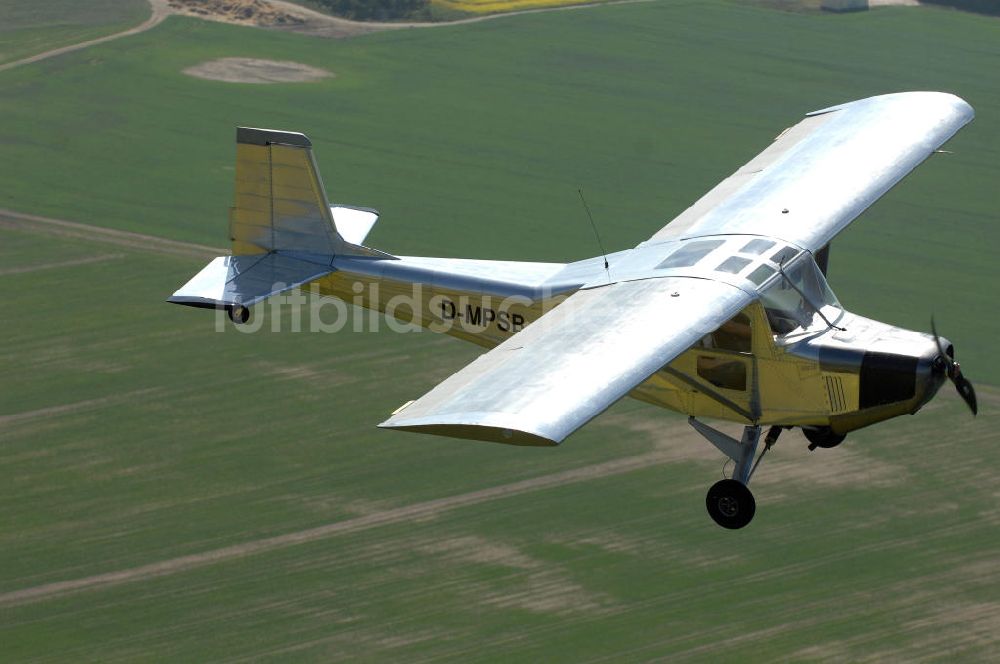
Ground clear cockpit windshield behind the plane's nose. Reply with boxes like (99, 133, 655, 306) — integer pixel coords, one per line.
(761, 253, 843, 336)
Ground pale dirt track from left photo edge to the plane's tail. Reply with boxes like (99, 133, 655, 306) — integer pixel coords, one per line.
(0, 208, 223, 258)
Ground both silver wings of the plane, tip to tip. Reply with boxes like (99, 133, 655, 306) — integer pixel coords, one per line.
(380, 92, 973, 445)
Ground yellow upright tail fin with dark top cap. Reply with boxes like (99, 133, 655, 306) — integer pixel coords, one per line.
(229, 127, 389, 258)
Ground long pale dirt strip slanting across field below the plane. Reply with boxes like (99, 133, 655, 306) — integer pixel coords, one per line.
(0, 450, 677, 607)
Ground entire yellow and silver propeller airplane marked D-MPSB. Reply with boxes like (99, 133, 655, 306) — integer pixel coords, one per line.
(169, 92, 976, 528)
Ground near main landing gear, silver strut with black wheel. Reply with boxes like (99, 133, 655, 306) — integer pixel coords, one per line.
(688, 417, 782, 530)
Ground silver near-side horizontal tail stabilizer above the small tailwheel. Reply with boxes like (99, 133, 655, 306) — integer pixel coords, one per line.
(167, 254, 334, 309)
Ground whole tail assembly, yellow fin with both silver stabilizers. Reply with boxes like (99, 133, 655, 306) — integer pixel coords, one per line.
(167, 127, 394, 310)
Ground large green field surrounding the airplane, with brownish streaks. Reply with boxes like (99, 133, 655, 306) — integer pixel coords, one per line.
(0, 2, 1000, 662)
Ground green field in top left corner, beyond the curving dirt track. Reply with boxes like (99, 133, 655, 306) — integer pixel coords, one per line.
(0, 0, 150, 64)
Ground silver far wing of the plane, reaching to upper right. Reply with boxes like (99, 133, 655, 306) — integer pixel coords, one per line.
(644, 92, 974, 252)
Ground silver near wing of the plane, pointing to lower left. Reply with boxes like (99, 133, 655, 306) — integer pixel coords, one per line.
(379, 277, 753, 445)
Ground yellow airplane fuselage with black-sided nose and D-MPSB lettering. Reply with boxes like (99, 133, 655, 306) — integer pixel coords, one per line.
(311, 238, 947, 436)
